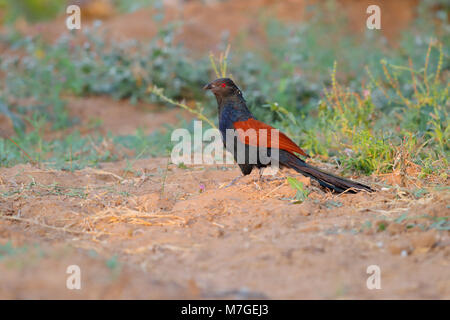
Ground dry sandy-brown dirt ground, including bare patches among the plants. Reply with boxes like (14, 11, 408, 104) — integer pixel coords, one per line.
(0, 0, 450, 299)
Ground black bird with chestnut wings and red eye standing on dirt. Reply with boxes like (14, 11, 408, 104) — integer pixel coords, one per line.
(203, 78, 374, 193)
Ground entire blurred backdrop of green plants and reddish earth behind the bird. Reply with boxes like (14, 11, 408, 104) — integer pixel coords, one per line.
(0, 0, 450, 180)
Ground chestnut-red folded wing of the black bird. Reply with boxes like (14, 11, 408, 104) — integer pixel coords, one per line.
(234, 118, 309, 157)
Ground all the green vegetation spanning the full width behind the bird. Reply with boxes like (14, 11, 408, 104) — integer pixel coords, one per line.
(0, 1, 450, 184)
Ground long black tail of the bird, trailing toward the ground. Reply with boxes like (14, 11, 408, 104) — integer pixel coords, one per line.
(280, 153, 375, 193)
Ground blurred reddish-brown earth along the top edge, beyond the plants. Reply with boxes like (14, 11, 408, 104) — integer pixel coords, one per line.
(10, 0, 418, 50)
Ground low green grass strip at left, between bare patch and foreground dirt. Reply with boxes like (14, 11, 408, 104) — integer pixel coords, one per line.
(0, 125, 176, 171)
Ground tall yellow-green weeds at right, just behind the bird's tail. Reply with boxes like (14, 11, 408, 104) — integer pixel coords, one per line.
(280, 39, 450, 178)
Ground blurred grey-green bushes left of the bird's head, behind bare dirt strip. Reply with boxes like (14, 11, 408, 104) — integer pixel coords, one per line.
(0, 25, 208, 131)
